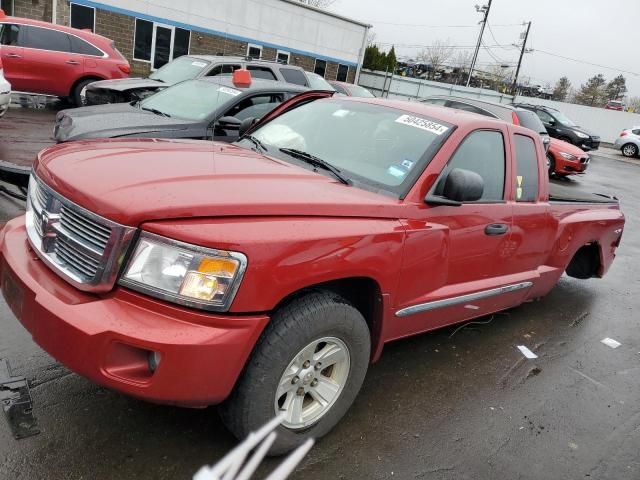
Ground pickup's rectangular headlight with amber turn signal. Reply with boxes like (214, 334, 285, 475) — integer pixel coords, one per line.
(120, 232, 247, 311)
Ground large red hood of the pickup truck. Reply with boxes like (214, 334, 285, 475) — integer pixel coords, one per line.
(34, 139, 403, 226)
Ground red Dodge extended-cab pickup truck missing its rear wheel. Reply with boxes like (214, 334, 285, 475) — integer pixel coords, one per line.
(0, 92, 624, 453)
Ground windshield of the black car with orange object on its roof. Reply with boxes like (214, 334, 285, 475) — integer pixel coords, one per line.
(140, 80, 242, 120)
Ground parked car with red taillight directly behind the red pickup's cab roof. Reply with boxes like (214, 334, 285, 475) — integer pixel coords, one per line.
(420, 95, 551, 151)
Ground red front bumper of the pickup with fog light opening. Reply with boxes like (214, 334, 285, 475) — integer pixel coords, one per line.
(0, 217, 269, 407)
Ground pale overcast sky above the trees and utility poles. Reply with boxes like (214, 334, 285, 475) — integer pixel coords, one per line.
(330, 0, 640, 96)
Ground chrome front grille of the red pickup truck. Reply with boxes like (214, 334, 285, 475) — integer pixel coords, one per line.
(26, 175, 135, 292)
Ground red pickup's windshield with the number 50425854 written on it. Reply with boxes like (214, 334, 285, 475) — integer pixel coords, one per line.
(248, 98, 453, 197)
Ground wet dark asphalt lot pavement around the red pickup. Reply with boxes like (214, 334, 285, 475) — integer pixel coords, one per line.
(0, 107, 640, 480)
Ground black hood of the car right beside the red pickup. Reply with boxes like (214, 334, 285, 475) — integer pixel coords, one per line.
(53, 103, 194, 142)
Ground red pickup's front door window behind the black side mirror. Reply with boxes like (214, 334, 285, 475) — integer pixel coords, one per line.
(434, 130, 505, 202)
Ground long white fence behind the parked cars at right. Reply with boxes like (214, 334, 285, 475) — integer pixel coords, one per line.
(359, 70, 640, 143)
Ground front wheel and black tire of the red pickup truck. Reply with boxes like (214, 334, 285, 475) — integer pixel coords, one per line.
(220, 291, 371, 455)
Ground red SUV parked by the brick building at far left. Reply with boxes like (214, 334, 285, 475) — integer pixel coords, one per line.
(0, 10, 130, 105)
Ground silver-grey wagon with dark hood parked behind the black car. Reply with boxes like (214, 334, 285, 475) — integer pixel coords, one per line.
(87, 55, 315, 105)
